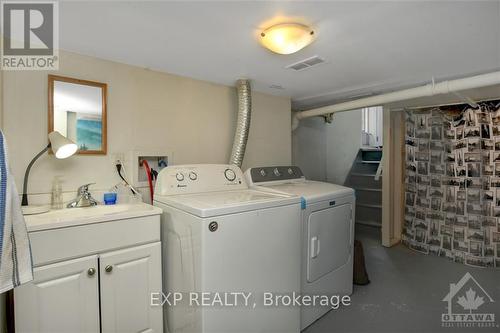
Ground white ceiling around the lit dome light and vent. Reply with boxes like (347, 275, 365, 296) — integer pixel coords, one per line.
(59, 1, 500, 109)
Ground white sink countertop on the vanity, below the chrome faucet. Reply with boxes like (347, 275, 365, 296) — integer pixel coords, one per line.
(24, 203, 161, 232)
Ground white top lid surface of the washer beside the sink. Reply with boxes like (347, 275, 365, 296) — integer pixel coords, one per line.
(155, 190, 300, 217)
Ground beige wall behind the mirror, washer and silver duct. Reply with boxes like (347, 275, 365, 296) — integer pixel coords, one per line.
(2, 52, 291, 198)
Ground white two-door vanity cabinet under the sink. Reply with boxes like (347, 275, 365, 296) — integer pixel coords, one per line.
(14, 205, 163, 333)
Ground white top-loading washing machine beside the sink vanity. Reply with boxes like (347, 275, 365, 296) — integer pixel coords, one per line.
(154, 164, 301, 333)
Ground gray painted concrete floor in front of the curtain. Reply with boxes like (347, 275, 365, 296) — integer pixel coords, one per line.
(304, 227, 500, 333)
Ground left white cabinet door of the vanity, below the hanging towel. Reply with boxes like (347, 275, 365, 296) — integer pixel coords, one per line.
(14, 256, 99, 333)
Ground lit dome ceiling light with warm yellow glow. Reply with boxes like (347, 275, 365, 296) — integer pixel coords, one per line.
(260, 23, 314, 54)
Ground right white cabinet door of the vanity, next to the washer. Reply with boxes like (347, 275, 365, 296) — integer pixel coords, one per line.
(100, 242, 163, 333)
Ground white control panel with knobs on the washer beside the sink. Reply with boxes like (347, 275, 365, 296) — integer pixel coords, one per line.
(155, 164, 248, 195)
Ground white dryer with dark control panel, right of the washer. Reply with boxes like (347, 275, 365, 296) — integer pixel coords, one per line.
(245, 166, 355, 329)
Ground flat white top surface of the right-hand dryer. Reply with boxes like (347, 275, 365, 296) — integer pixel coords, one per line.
(256, 180, 354, 203)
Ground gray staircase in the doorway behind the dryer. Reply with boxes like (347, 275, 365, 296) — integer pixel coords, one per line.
(345, 147, 382, 227)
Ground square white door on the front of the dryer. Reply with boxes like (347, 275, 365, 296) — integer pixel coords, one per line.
(307, 203, 352, 282)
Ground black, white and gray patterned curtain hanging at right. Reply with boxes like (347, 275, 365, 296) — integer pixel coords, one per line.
(403, 101, 500, 268)
